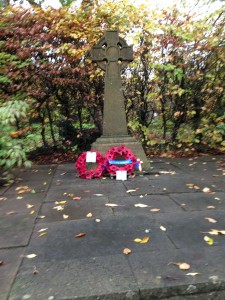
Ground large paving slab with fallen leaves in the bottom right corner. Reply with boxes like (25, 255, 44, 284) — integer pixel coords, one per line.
(128, 247, 225, 300)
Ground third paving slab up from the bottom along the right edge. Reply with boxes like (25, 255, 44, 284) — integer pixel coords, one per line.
(170, 192, 225, 211)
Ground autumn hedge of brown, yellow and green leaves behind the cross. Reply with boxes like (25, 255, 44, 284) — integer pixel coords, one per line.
(0, 1, 225, 171)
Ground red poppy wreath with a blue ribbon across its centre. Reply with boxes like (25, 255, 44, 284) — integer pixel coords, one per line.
(106, 145, 137, 175)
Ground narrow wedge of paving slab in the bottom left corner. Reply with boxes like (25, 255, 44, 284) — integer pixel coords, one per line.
(0, 248, 25, 300)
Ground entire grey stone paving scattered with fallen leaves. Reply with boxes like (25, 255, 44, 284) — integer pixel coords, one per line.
(0, 156, 225, 300)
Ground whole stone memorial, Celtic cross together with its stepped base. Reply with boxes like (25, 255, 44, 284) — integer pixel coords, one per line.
(91, 30, 150, 171)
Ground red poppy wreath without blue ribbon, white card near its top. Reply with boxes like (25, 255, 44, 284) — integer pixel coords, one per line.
(75, 151, 105, 179)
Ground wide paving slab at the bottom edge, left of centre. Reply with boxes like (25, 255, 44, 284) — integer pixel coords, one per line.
(9, 255, 139, 300)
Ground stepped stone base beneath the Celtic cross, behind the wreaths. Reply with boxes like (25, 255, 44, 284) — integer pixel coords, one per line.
(91, 135, 150, 172)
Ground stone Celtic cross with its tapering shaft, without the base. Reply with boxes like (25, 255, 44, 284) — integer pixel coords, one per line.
(91, 30, 133, 136)
